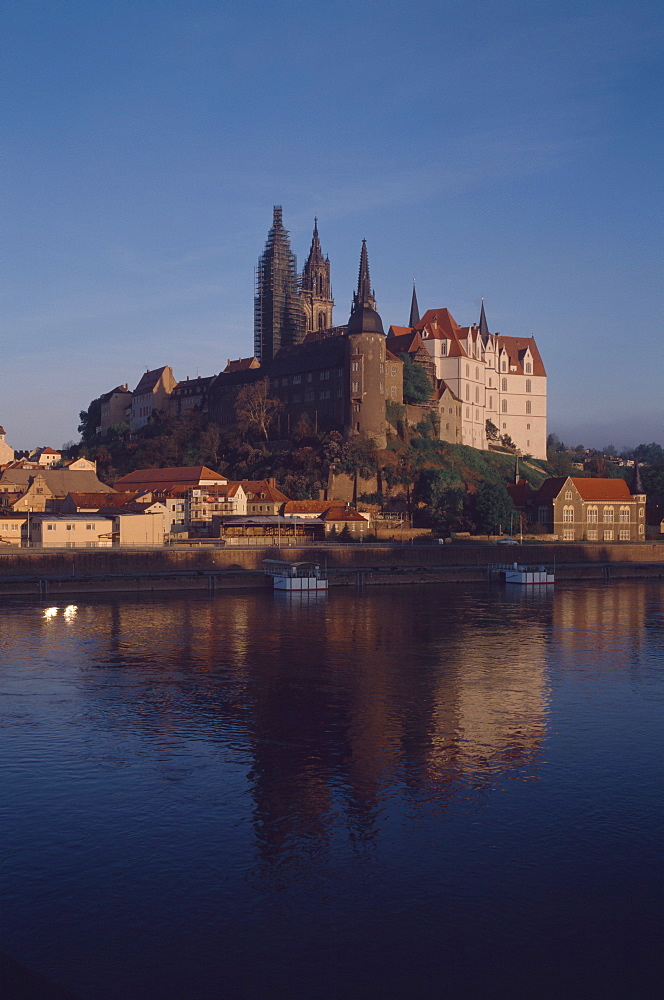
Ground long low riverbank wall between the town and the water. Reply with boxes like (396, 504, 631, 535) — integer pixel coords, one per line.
(0, 542, 664, 598)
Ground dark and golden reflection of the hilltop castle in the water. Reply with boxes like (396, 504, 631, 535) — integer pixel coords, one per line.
(14, 588, 550, 858)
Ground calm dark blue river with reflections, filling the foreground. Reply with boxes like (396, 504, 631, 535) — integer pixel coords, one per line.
(0, 582, 664, 1000)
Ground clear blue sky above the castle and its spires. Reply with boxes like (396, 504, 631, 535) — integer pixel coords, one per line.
(0, 0, 664, 448)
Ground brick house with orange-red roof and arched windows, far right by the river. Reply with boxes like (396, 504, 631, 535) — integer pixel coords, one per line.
(532, 476, 646, 542)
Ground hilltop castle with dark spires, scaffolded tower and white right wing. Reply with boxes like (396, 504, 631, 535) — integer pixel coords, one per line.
(94, 205, 547, 459)
